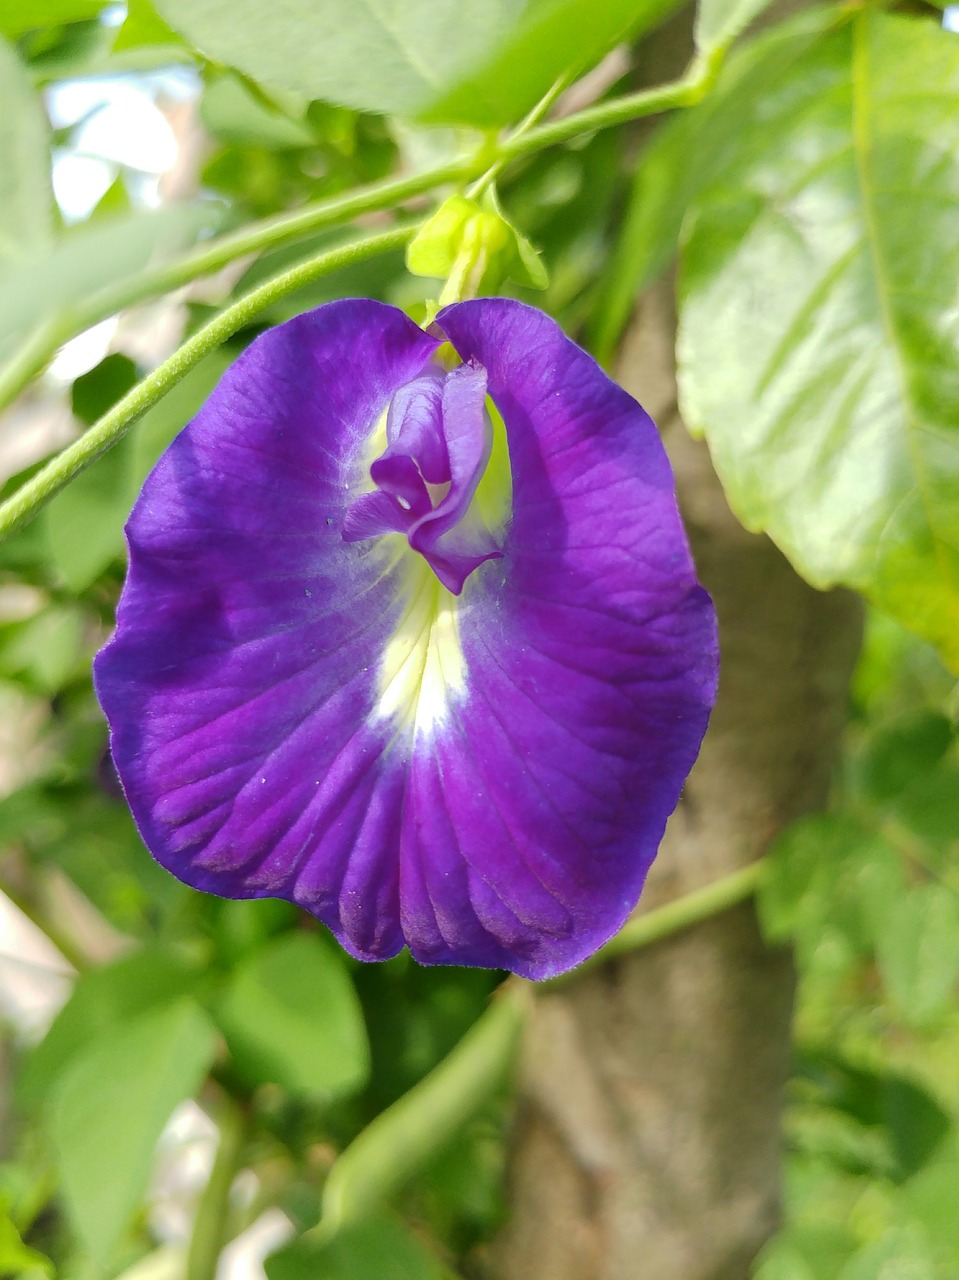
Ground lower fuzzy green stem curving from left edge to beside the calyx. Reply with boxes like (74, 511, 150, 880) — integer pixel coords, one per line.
(0, 224, 419, 540)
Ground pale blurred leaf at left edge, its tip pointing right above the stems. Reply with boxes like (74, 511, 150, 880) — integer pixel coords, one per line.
(0, 205, 220, 355)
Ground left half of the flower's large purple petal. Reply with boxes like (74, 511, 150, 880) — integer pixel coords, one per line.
(95, 301, 437, 957)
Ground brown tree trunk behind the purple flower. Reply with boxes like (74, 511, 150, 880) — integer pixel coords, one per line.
(493, 272, 860, 1280)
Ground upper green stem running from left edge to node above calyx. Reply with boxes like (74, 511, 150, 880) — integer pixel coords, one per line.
(0, 151, 468, 410)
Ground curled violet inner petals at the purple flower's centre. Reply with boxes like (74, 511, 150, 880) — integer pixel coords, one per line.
(343, 364, 502, 595)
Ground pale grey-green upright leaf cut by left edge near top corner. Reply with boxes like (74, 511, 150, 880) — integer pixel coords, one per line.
(0, 38, 54, 262)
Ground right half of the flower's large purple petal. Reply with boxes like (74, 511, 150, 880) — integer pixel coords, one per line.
(384, 298, 717, 978)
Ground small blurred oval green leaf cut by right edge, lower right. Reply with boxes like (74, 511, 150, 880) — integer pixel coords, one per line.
(877, 884, 959, 1027)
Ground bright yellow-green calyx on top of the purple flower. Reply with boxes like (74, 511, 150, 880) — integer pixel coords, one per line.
(406, 187, 548, 306)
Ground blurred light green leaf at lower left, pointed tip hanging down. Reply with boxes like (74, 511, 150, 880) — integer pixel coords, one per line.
(49, 1000, 216, 1266)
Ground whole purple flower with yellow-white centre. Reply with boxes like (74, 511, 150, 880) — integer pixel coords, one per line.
(96, 298, 717, 978)
